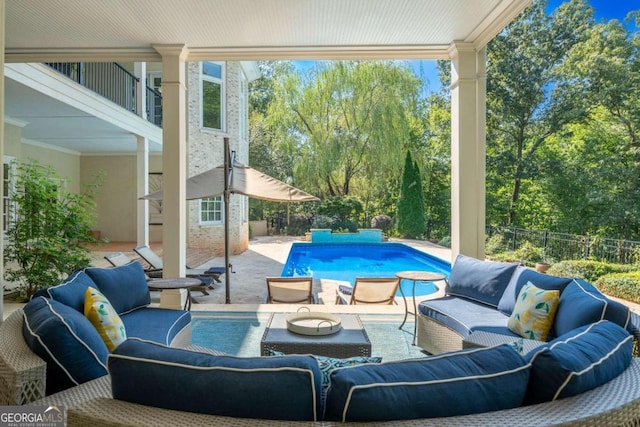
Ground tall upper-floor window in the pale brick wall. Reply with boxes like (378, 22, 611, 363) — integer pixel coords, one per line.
(205, 62, 225, 130)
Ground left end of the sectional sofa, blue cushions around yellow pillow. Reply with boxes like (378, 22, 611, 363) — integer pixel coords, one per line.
(22, 261, 191, 394)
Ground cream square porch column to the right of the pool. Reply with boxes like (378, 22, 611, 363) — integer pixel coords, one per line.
(449, 43, 486, 259)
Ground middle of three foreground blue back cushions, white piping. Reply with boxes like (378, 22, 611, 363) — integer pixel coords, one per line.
(324, 344, 530, 422)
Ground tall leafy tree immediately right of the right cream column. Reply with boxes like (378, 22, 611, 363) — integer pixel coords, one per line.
(487, 0, 594, 224)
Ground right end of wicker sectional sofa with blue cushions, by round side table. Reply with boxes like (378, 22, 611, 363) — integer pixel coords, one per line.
(416, 255, 640, 354)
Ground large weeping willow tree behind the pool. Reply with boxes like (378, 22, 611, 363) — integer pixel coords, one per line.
(268, 61, 421, 200)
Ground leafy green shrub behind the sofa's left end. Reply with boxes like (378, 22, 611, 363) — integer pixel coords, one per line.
(4, 162, 99, 300)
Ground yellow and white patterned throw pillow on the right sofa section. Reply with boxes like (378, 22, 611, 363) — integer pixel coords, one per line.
(507, 282, 560, 341)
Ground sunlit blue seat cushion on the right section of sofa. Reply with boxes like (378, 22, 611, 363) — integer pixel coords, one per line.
(418, 296, 520, 338)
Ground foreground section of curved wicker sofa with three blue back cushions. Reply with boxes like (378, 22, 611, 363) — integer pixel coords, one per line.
(22, 320, 640, 427)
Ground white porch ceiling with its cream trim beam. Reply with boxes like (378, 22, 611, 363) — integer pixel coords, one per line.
(5, 0, 531, 62)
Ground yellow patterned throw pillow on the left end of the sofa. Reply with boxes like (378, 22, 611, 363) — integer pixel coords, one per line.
(84, 286, 127, 352)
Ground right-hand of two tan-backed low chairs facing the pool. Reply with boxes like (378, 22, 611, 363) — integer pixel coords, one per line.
(336, 277, 400, 305)
